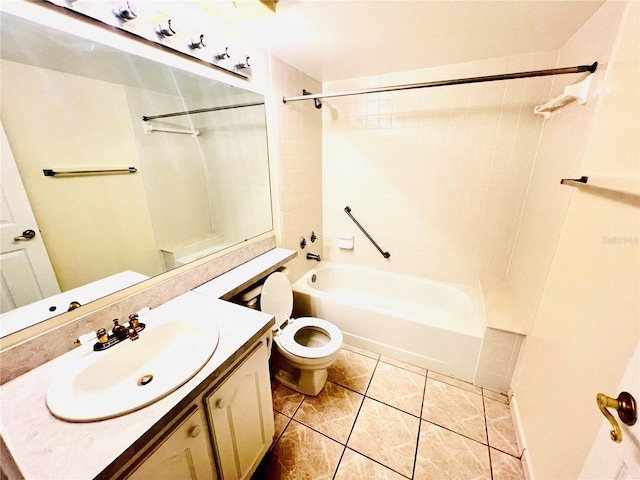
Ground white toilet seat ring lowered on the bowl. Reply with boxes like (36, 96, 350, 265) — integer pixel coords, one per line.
(274, 317, 342, 359)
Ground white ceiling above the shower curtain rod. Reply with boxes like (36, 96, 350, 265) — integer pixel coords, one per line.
(236, 0, 604, 82)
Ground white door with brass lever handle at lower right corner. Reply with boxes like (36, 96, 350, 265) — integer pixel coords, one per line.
(580, 344, 640, 480)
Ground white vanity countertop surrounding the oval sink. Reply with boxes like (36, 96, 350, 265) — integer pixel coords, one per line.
(0, 292, 273, 480)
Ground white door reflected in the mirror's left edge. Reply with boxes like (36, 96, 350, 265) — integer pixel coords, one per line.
(0, 124, 60, 313)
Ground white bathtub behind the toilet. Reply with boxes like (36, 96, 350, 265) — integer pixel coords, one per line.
(293, 262, 484, 382)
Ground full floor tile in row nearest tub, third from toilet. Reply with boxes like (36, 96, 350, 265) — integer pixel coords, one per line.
(422, 378, 487, 444)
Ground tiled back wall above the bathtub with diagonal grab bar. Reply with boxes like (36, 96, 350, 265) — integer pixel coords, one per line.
(322, 52, 557, 286)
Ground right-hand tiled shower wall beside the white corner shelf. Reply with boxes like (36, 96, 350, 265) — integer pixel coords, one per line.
(506, 2, 626, 332)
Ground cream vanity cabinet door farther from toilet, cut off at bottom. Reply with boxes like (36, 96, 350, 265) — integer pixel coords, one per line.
(127, 407, 218, 480)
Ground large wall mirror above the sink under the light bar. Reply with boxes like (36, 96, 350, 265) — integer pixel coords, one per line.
(0, 8, 273, 338)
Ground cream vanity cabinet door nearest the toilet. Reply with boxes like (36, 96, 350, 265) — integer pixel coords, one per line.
(205, 342, 274, 480)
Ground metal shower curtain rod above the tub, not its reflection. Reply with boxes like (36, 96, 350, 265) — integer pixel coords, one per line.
(282, 62, 598, 103)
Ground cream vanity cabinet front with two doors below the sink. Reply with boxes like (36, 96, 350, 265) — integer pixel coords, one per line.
(116, 337, 274, 480)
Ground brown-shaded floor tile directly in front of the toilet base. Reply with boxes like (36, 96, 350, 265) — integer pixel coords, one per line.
(293, 382, 364, 444)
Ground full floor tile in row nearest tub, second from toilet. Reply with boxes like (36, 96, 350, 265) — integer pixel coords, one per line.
(367, 362, 425, 417)
